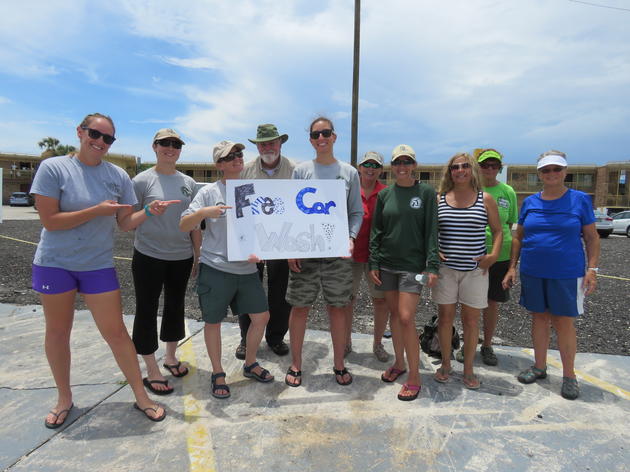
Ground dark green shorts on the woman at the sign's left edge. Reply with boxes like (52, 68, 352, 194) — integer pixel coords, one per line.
(197, 264, 269, 324)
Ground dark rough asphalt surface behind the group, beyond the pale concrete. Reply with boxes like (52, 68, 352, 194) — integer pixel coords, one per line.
(0, 207, 630, 355)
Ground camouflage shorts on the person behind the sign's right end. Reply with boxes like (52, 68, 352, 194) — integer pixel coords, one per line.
(287, 257, 352, 307)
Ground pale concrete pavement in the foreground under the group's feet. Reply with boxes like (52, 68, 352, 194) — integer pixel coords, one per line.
(0, 304, 630, 472)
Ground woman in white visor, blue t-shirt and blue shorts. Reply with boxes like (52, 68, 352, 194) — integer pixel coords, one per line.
(503, 151, 599, 400)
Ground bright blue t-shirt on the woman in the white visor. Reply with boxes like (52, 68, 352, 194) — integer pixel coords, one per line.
(518, 189, 595, 279)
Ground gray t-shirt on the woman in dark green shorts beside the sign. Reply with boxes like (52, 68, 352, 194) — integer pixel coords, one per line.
(182, 181, 258, 274)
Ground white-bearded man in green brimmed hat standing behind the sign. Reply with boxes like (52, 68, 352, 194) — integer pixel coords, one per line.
(236, 124, 295, 359)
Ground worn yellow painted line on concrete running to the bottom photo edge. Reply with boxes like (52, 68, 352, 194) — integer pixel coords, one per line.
(179, 323, 217, 472)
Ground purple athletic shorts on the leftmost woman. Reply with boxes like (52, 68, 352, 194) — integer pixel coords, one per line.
(32, 264, 120, 295)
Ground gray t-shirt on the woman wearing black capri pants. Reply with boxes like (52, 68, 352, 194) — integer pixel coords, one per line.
(133, 167, 196, 261)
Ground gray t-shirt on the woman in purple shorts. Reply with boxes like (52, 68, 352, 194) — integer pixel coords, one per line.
(31, 156, 137, 271)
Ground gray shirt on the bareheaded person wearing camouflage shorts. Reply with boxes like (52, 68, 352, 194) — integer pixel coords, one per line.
(293, 160, 363, 238)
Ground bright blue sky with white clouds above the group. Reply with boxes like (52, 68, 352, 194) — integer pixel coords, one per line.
(0, 0, 630, 165)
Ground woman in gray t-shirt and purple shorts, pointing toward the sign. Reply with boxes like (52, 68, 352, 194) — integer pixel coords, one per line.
(31, 113, 177, 429)
